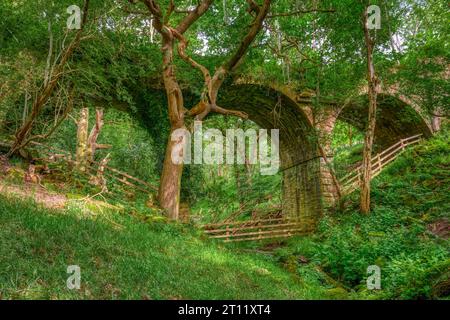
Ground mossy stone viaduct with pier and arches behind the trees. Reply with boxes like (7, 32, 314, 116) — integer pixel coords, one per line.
(219, 82, 433, 231)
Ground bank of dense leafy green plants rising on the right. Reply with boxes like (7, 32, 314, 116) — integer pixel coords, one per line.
(277, 130, 450, 299)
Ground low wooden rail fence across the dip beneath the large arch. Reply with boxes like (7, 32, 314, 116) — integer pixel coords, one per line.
(202, 218, 306, 242)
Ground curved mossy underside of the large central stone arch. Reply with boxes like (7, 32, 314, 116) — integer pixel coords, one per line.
(219, 84, 322, 231)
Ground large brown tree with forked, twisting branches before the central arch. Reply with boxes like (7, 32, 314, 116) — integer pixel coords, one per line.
(133, 0, 271, 220)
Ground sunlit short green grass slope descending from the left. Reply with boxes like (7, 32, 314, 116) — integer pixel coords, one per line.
(0, 197, 323, 299)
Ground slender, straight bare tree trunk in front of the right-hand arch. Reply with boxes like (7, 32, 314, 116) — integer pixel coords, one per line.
(360, 10, 378, 214)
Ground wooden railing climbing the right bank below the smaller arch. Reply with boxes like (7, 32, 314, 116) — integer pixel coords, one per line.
(339, 134, 422, 195)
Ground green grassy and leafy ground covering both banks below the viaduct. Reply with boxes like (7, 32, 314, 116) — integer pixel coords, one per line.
(0, 132, 450, 299)
